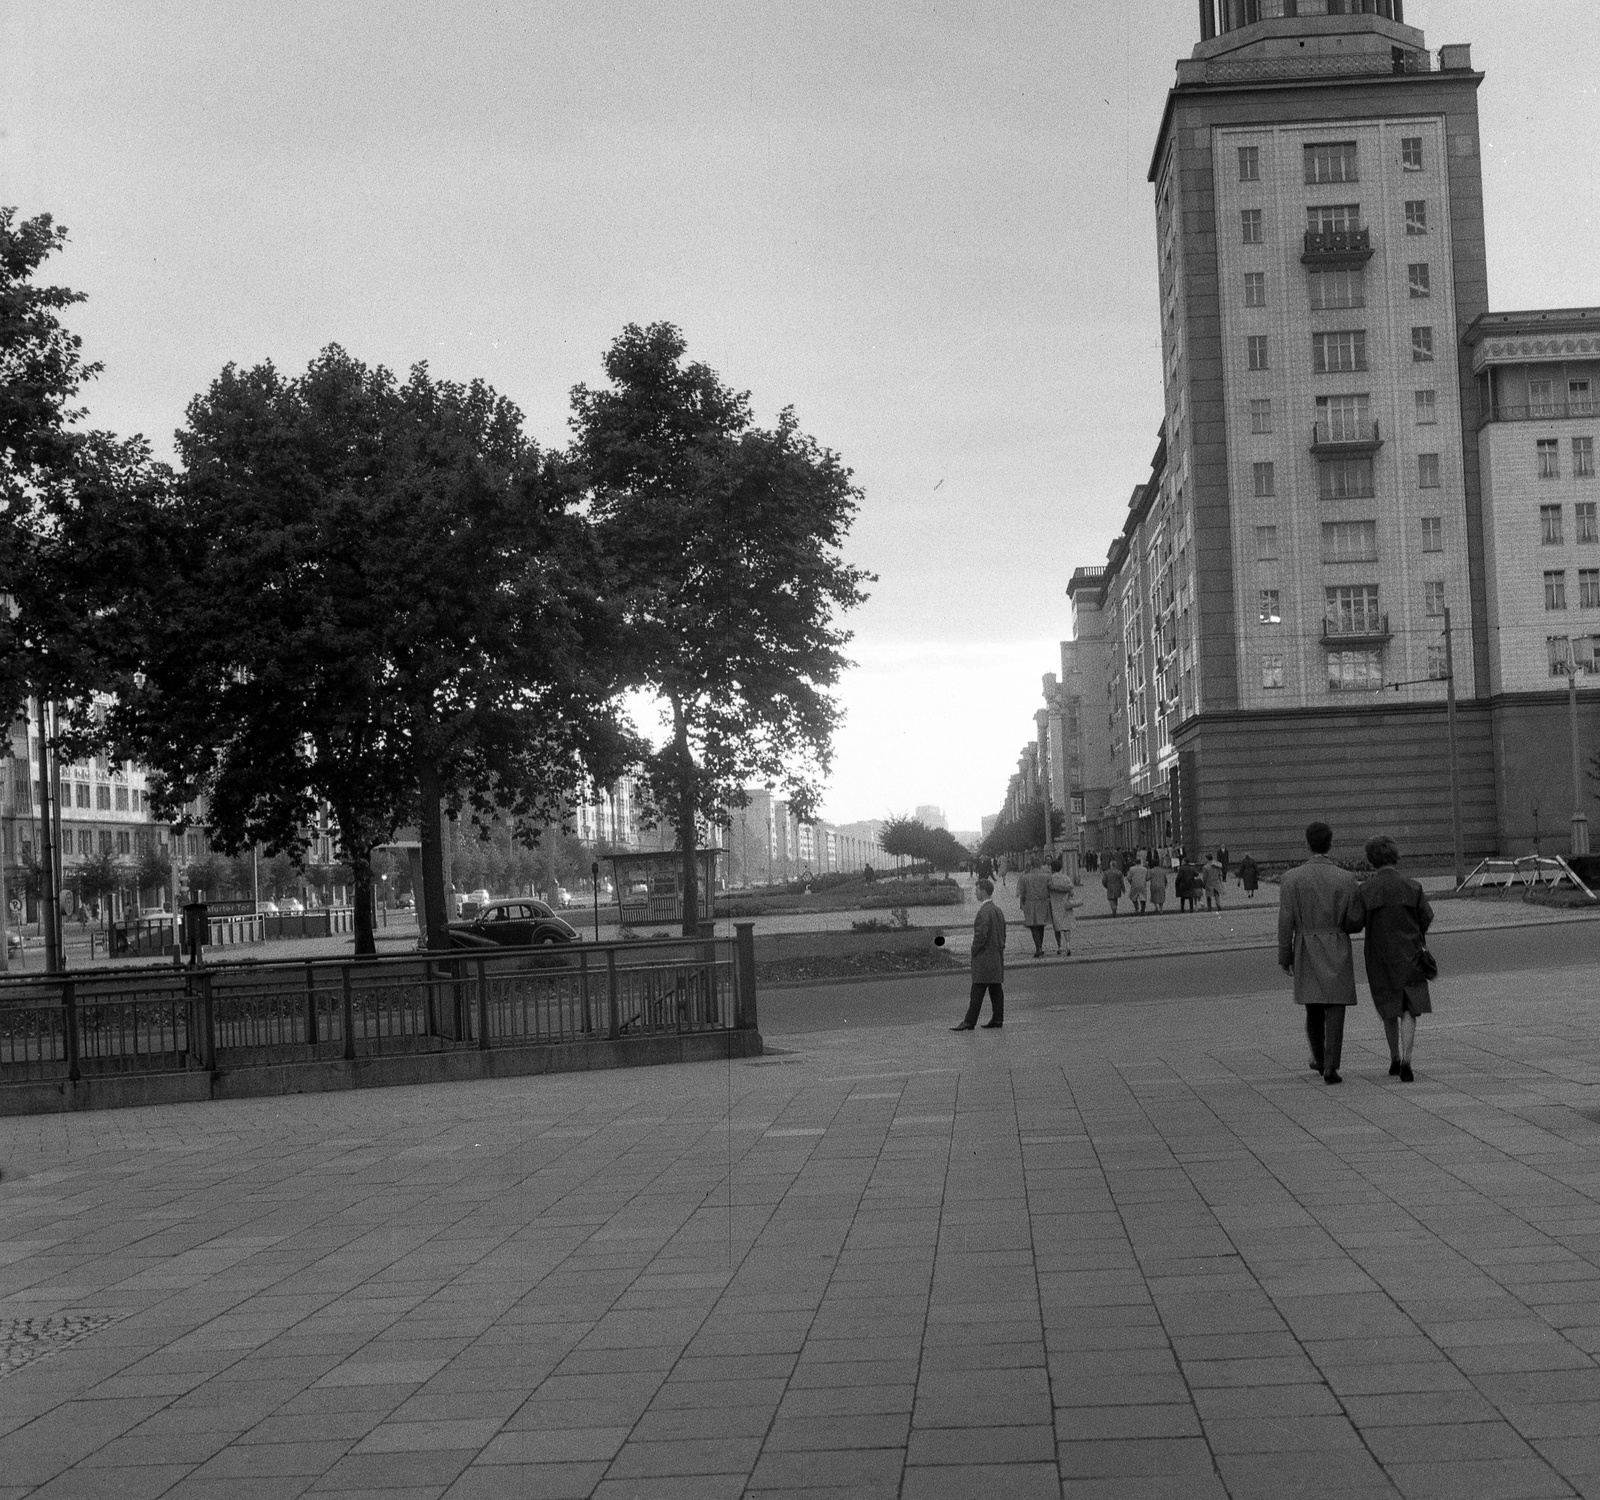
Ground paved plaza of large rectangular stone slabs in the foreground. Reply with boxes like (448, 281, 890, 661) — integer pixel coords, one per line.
(0, 928, 1600, 1500)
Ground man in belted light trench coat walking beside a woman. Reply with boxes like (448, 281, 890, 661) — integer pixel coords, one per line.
(1278, 824, 1363, 1083)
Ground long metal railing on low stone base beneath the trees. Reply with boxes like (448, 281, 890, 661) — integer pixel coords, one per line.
(0, 926, 755, 1084)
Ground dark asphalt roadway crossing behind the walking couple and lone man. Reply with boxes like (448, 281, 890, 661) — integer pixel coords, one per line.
(758, 921, 1600, 1038)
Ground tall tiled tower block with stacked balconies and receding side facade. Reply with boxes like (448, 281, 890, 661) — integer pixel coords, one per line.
(1126, 0, 1496, 857)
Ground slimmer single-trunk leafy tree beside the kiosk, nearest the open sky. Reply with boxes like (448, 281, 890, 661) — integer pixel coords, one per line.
(573, 323, 872, 934)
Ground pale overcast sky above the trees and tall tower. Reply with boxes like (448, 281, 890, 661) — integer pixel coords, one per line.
(0, 0, 1600, 828)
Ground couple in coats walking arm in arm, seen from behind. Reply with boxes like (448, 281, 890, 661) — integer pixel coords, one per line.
(1278, 824, 1438, 1084)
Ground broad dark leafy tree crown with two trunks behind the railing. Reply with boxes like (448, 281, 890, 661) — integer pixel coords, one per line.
(104, 347, 627, 953)
